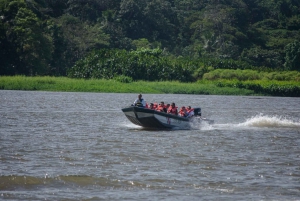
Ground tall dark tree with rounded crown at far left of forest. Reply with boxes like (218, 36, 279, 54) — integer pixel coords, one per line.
(12, 8, 53, 75)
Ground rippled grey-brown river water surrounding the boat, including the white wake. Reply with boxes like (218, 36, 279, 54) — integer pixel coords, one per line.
(0, 91, 300, 200)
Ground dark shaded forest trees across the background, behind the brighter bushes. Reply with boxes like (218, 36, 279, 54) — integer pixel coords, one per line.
(0, 0, 300, 77)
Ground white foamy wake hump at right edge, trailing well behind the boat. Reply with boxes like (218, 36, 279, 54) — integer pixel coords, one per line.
(238, 114, 300, 128)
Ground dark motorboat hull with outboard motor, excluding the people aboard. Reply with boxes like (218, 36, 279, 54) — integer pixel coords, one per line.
(122, 106, 214, 129)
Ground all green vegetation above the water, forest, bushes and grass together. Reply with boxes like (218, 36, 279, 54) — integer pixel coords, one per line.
(0, 0, 300, 96)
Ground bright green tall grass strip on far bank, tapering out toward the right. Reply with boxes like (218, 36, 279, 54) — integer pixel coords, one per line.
(0, 76, 255, 95)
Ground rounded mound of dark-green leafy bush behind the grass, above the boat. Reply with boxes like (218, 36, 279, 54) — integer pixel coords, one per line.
(68, 48, 193, 82)
